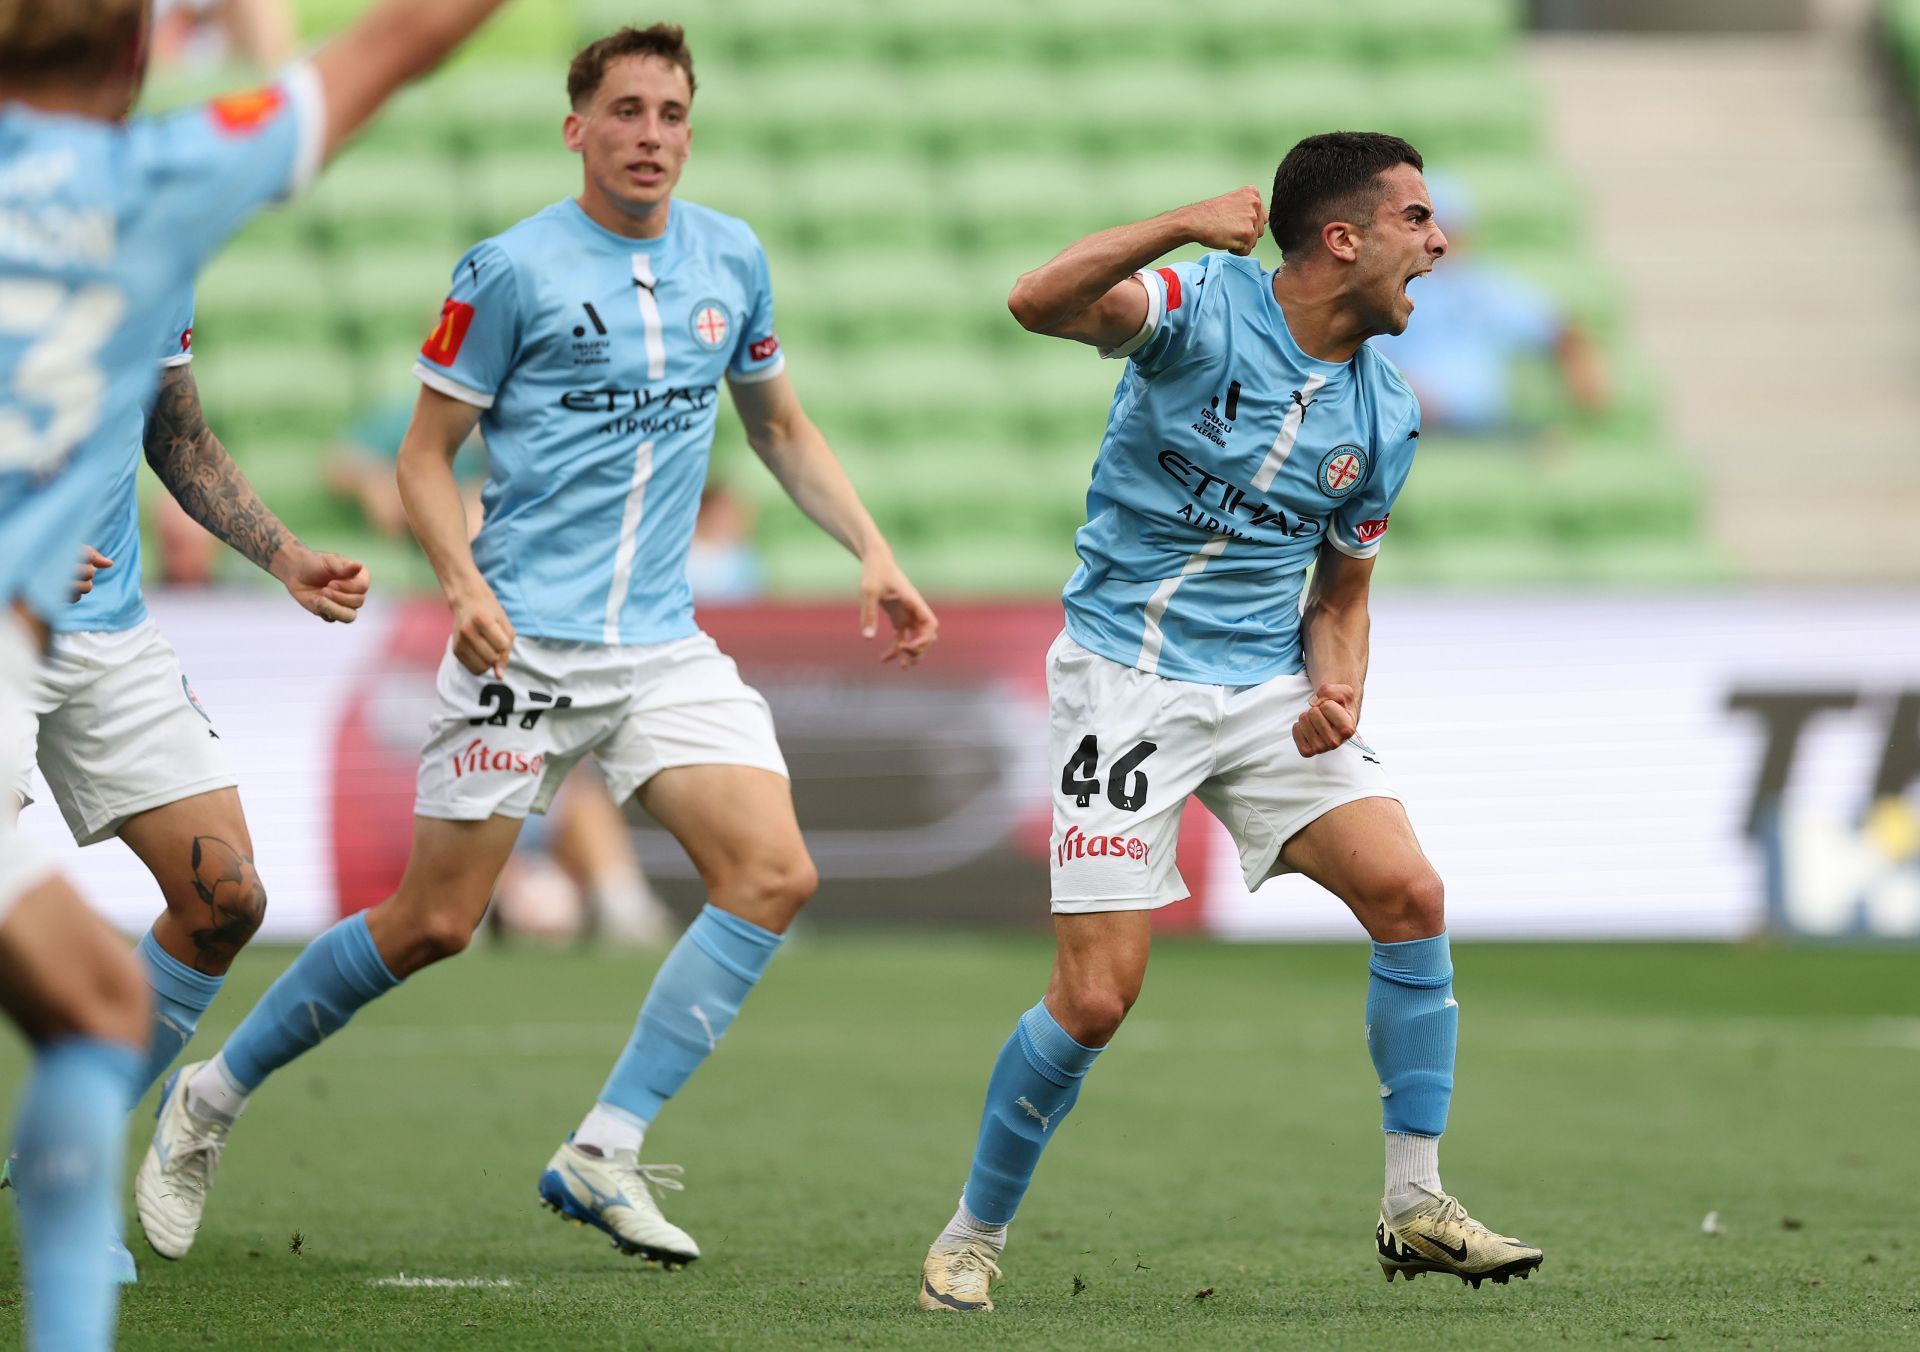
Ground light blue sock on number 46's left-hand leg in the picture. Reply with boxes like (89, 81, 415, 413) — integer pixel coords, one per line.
(960, 1001, 1100, 1225)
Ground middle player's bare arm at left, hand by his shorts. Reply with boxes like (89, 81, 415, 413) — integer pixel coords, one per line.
(397, 386, 513, 676)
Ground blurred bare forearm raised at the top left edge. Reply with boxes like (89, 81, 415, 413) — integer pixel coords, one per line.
(313, 0, 505, 163)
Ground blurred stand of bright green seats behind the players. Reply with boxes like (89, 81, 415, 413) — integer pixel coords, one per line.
(145, 0, 1712, 595)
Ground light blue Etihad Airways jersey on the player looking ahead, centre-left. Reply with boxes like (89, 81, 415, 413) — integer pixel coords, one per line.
(413, 200, 785, 643)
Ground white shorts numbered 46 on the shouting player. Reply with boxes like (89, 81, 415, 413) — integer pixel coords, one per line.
(1046, 634, 1400, 914)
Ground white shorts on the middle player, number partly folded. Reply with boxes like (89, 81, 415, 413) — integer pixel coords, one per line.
(413, 634, 787, 822)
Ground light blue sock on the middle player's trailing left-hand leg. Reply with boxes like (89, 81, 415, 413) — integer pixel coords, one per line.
(221, 910, 399, 1093)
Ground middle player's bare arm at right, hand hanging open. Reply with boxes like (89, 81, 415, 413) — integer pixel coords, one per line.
(728, 373, 941, 666)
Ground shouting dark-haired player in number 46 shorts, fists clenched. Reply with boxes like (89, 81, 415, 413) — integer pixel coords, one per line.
(920, 133, 1540, 1310)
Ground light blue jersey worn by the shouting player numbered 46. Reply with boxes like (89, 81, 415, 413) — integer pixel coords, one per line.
(1064, 254, 1421, 686)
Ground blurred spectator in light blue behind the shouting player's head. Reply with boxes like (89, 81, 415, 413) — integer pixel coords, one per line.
(1373, 175, 1611, 432)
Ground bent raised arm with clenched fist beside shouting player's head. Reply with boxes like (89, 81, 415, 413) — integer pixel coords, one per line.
(1006, 186, 1267, 348)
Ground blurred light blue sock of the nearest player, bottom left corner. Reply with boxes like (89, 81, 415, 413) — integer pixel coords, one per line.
(13, 1037, 140, 1352)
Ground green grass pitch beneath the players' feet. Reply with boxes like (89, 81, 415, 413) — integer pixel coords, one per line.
(0, 935, 1920, 1352)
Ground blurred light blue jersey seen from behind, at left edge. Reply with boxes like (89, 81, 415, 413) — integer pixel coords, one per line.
(0, 65, 324, 620)
